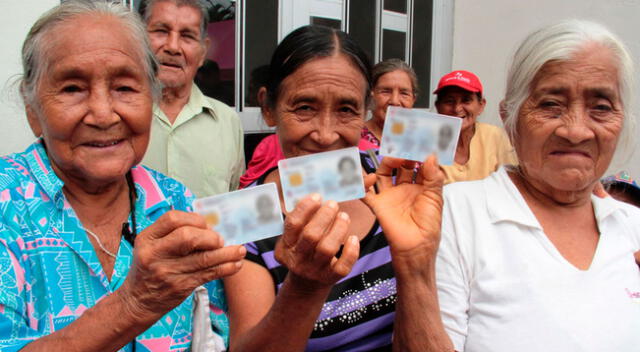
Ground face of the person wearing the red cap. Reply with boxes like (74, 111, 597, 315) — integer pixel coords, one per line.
(436, 86, 486, 131)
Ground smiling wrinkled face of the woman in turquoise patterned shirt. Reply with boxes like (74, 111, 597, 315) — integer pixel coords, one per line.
(27, 16, 152, 188)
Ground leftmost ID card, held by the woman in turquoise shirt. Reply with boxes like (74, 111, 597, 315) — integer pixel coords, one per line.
(193, 183, 283, 245)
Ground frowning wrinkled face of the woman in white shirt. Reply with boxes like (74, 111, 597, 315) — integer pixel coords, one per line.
(512, 44, 624, 191)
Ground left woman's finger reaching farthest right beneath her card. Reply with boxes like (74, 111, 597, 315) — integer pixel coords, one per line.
(178, 245, 247, 274)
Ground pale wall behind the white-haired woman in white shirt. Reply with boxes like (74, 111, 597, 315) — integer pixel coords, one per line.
(452, 0, 640, 179)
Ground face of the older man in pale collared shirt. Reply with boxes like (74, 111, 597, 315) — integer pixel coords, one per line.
(147, 1, 208, 88)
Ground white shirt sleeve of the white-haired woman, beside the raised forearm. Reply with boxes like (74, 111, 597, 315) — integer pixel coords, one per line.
(436, 194, 469, 351)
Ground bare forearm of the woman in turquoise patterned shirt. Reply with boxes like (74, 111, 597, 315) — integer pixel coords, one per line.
(21, 291, 162, 352)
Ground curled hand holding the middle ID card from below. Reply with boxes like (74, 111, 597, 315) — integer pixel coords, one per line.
(275, 194, 360, 289)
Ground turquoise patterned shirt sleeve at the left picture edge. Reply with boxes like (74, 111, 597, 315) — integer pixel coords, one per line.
(0, 224, 43, 352)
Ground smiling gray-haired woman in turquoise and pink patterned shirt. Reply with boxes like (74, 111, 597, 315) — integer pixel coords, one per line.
(0, 1, 245, 351)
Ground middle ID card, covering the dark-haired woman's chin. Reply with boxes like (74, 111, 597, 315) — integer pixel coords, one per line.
(278, 147, 364, 211)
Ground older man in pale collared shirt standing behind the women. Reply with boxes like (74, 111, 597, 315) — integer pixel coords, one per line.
(140, 0, 244, 197)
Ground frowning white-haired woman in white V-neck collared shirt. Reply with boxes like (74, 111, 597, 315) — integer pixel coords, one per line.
(436, 20, 640, 351)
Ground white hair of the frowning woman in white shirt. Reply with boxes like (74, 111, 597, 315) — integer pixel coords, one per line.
(501, 20, 636, 157)
